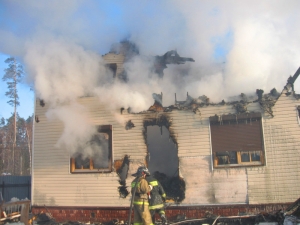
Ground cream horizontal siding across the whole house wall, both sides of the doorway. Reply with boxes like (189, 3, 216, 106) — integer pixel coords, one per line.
(32, 87, 300, 207)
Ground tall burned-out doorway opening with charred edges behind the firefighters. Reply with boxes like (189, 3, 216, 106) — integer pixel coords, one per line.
(144, 115, 185, 203)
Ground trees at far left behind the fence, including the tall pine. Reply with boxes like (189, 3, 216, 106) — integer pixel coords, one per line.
(0, 57, 33, 175)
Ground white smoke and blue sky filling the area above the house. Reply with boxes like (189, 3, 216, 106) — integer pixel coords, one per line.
(0, 0, 300, 154)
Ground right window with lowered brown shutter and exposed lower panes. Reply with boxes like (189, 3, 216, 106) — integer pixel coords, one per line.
(209, 113, 264, 167)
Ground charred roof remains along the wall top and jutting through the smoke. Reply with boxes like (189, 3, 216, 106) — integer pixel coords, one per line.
(104, 40, 300, 117)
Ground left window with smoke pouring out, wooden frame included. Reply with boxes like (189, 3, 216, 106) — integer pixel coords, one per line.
(70, 125, 112, 173)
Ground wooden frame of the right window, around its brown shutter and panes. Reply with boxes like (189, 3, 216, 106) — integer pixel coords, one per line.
(209, 113, 266, 169)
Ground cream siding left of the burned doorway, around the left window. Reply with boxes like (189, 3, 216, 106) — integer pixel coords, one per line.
(32, 97, 146, 206)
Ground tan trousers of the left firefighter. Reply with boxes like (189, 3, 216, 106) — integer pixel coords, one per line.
(133, 200, 153, 225)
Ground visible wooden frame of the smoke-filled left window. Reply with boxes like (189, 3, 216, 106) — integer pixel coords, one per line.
(70, 125, 113, 174)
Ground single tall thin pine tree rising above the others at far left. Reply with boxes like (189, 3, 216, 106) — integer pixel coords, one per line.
(2, 57, 24, 174)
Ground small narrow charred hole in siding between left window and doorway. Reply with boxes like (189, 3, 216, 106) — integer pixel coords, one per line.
(114, 155, 129, 198)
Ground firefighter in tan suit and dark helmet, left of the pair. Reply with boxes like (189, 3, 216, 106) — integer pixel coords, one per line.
(131, 166, 153, 225)
